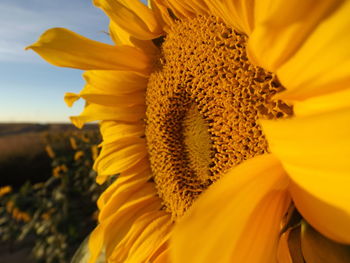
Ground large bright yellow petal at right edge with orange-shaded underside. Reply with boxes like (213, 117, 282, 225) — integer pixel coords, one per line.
(261, 91, 350, 243)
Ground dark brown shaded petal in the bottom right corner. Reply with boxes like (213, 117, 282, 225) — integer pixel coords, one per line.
(301, 222, 350, 263)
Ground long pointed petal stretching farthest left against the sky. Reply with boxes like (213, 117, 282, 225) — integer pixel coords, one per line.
(27, 28, 150, 74)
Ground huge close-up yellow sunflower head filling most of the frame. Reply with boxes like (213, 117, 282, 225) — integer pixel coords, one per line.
(29, 0, 350, 263)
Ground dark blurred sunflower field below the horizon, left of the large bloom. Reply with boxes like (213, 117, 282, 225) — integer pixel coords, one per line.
(0, 124, 104, 263)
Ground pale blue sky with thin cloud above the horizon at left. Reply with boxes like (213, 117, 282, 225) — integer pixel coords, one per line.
(0, 0, 111, 123)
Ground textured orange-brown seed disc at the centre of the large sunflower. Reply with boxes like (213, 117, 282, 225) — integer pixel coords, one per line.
(146, 17, 293, 219)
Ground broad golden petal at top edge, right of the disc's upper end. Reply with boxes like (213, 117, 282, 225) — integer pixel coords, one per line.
(248, 0, 342, 72)
